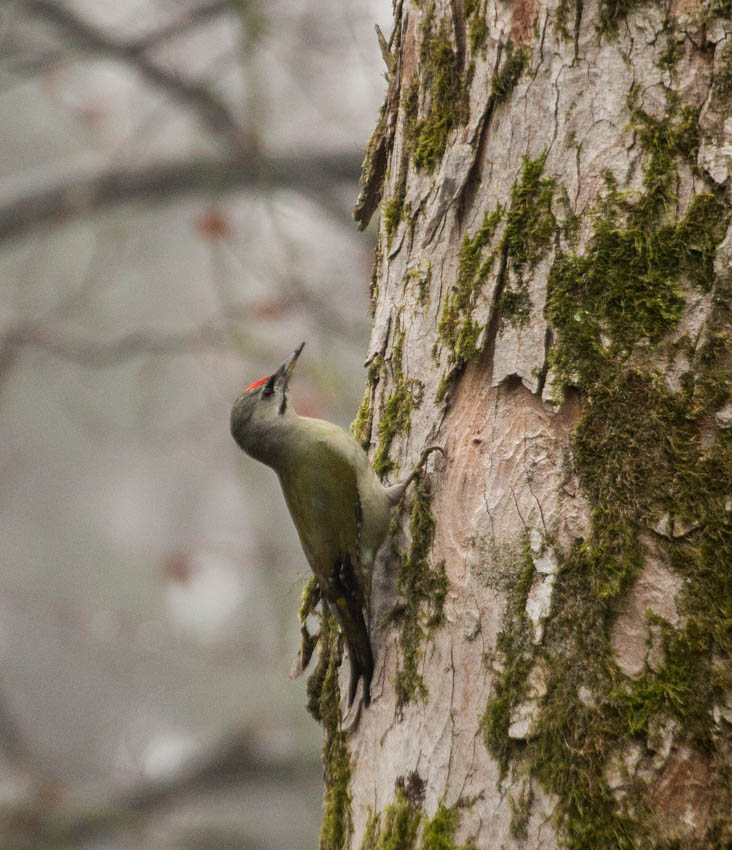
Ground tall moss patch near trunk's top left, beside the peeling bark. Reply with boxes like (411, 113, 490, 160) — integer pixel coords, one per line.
(412, 10, 469, 172)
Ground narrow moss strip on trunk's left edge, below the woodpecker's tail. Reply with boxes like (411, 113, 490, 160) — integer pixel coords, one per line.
(318, 610, 353, 850)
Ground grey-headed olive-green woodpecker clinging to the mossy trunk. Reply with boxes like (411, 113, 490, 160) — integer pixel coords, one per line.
(231, 342, 444, 708)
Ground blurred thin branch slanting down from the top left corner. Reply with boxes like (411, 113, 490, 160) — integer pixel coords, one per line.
(25, 0, 246, 150)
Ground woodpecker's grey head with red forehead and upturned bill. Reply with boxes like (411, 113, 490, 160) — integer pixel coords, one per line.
(231, 342, 305, 465)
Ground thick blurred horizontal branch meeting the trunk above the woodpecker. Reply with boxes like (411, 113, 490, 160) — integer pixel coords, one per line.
(0, 153, 362, 242)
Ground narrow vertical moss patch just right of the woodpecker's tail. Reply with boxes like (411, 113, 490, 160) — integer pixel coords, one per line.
(396, 486, 447, 708)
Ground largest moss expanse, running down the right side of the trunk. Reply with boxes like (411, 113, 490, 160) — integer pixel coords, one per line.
(482, 86, 732, 850)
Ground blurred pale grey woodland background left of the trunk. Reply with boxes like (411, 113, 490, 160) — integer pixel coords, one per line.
(0, 0, 391, 850)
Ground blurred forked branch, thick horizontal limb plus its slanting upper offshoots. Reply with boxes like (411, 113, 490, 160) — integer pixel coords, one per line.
(0, 0, 362, 242)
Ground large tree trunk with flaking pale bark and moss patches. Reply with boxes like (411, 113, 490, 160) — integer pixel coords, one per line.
(310, 0, 732, 850)
